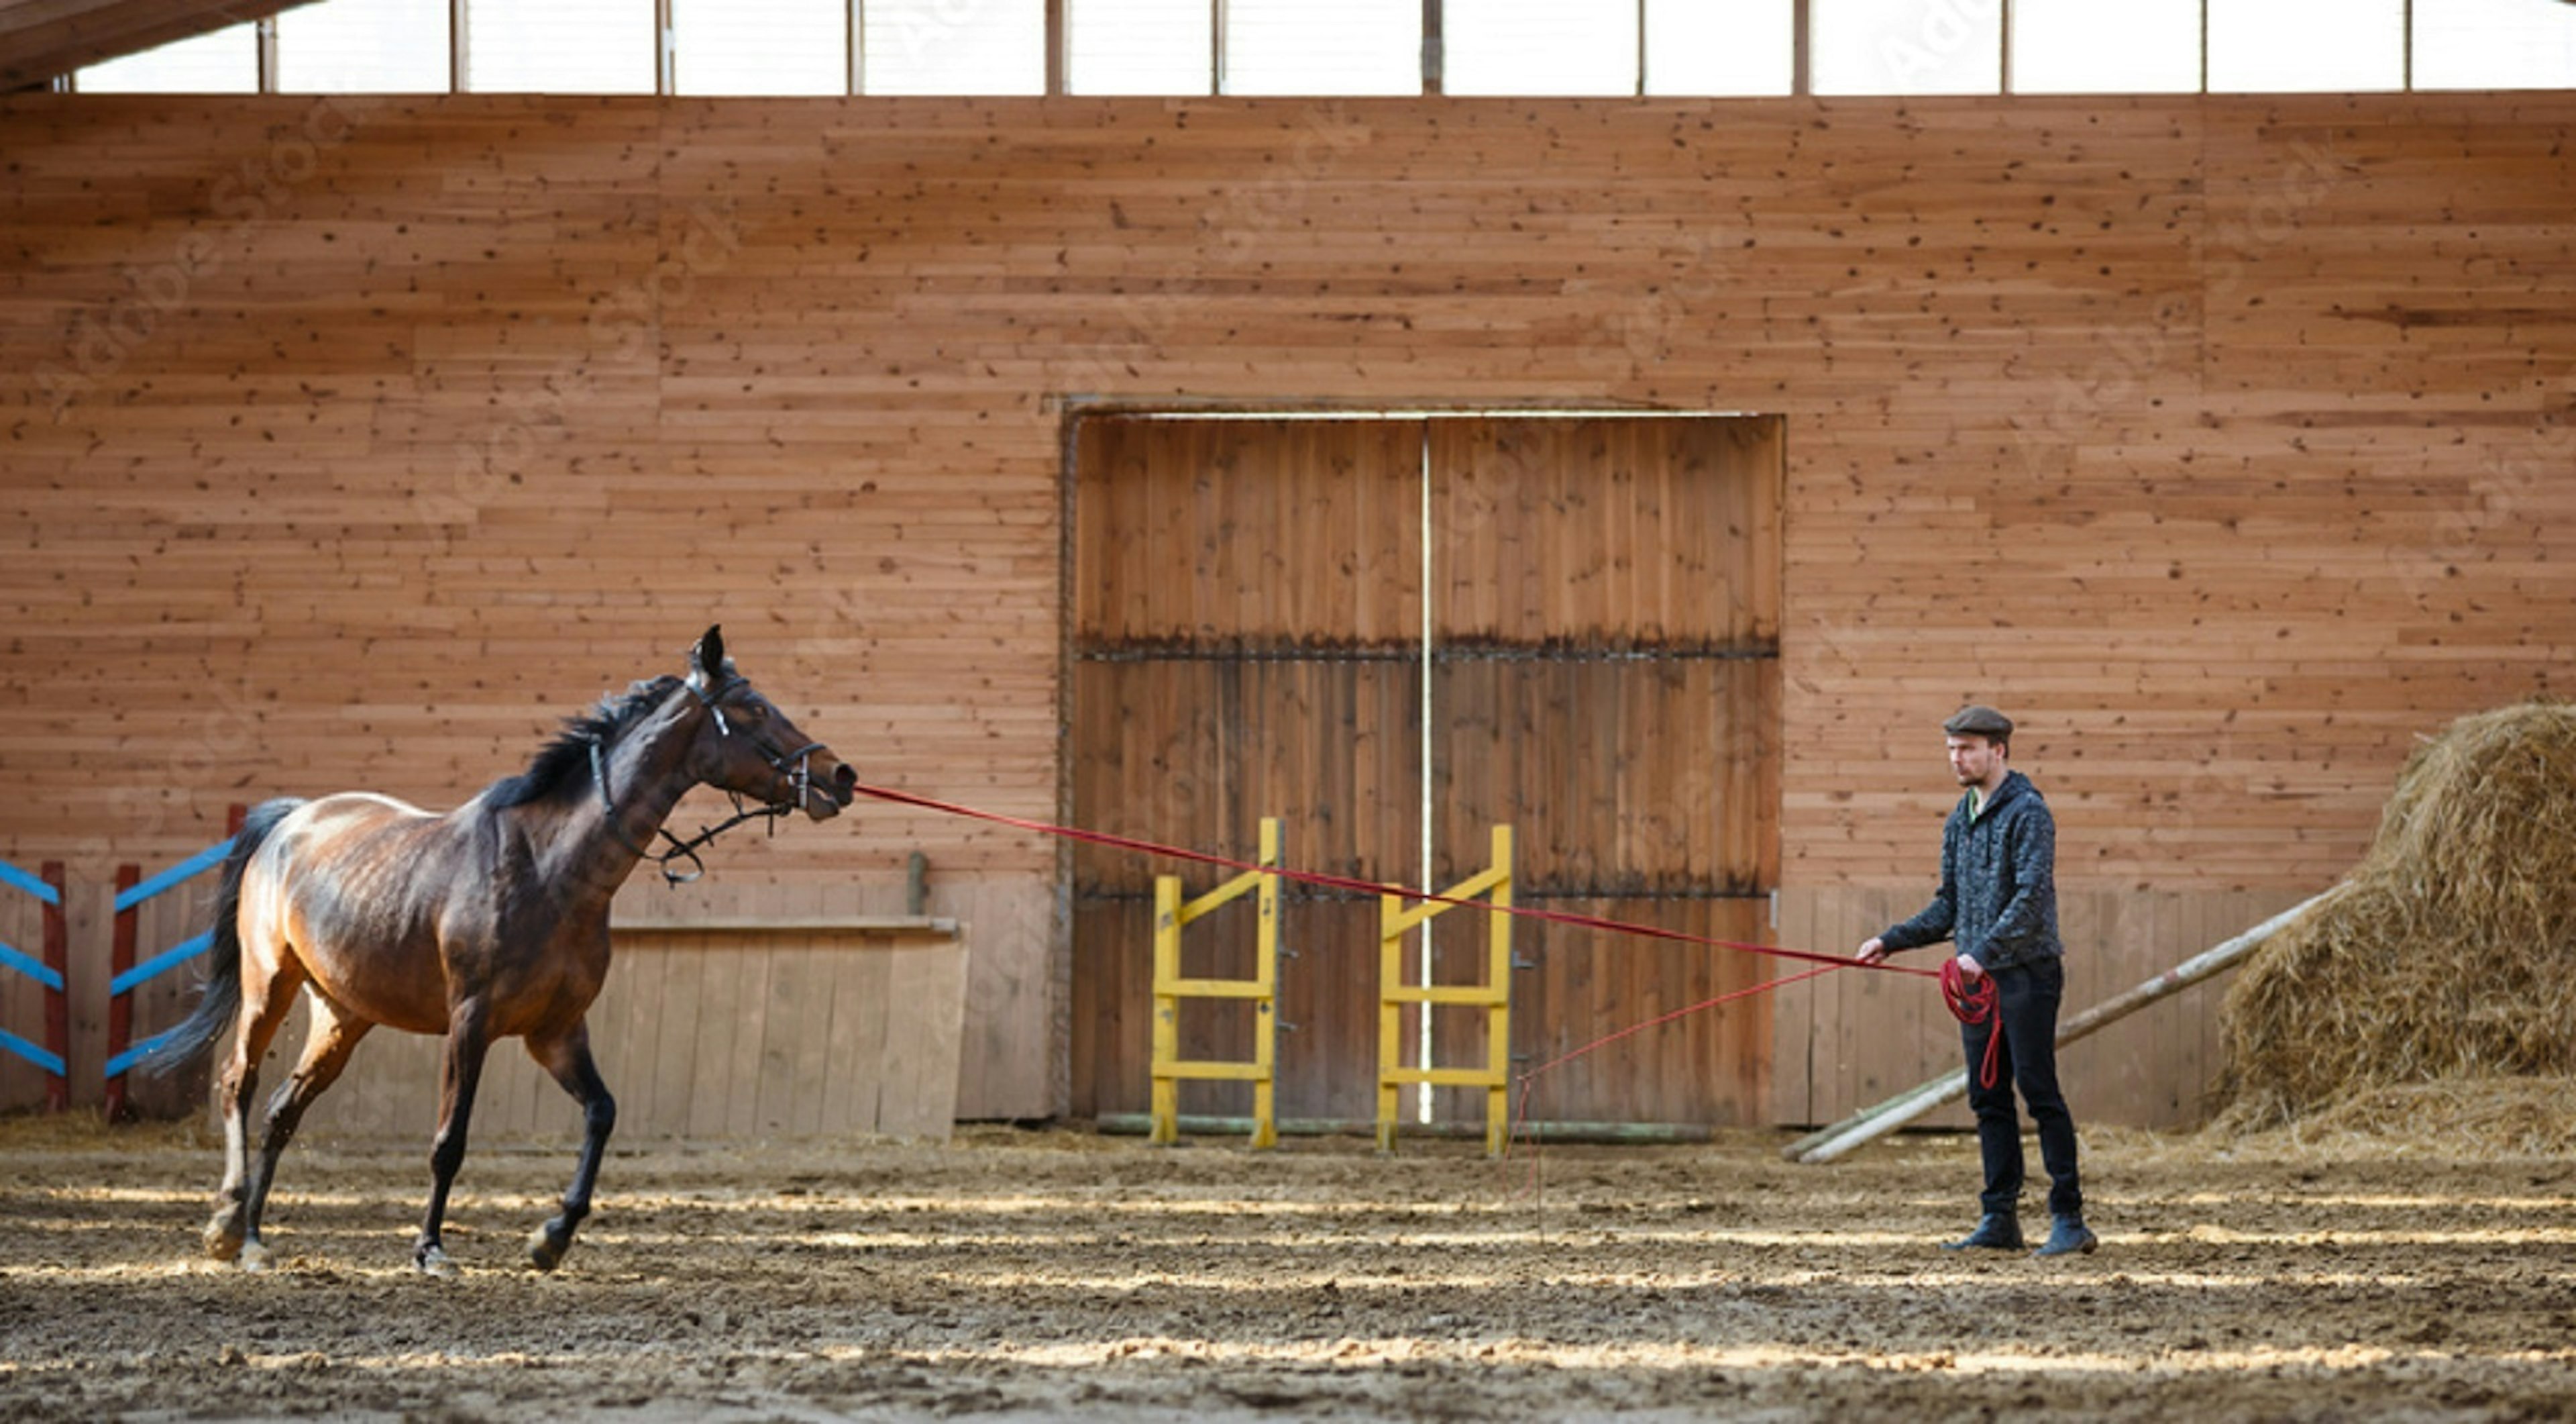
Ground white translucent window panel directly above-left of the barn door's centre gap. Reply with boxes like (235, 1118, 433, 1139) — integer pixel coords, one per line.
(1218, 0, 1422, 95)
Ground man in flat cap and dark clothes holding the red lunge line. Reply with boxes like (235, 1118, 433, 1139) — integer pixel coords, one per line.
(1858, 705, 2094, 1257)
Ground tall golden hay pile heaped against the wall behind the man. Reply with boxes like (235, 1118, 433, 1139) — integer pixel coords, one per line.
(2215, 703, 2576, 1141)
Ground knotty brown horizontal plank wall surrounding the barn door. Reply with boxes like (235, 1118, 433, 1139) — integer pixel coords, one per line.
(0, 93, 2576, 1133)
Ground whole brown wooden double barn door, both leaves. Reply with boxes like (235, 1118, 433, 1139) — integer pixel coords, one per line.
(1069, 407, 1780, 1123)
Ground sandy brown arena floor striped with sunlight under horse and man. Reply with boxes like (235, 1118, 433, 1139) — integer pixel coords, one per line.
(0, 1120, 2576, 1424)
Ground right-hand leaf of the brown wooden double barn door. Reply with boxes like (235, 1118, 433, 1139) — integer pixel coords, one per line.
(1430, 417, 1782, 1123)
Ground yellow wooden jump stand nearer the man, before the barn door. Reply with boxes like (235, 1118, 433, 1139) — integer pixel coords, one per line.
(1378, 827, 1512, 1156)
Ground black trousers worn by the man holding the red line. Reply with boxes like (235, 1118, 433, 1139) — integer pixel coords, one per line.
(1960, 958, 2084, 1215)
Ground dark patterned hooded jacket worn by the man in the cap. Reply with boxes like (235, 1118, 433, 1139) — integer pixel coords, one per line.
(1880, 772, 2066, 968)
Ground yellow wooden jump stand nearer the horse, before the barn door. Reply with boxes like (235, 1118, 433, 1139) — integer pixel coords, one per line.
(1151, 816, 1280, 1148)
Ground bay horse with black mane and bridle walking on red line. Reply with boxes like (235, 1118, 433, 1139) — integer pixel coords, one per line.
(144, 625, 858, 1274)
